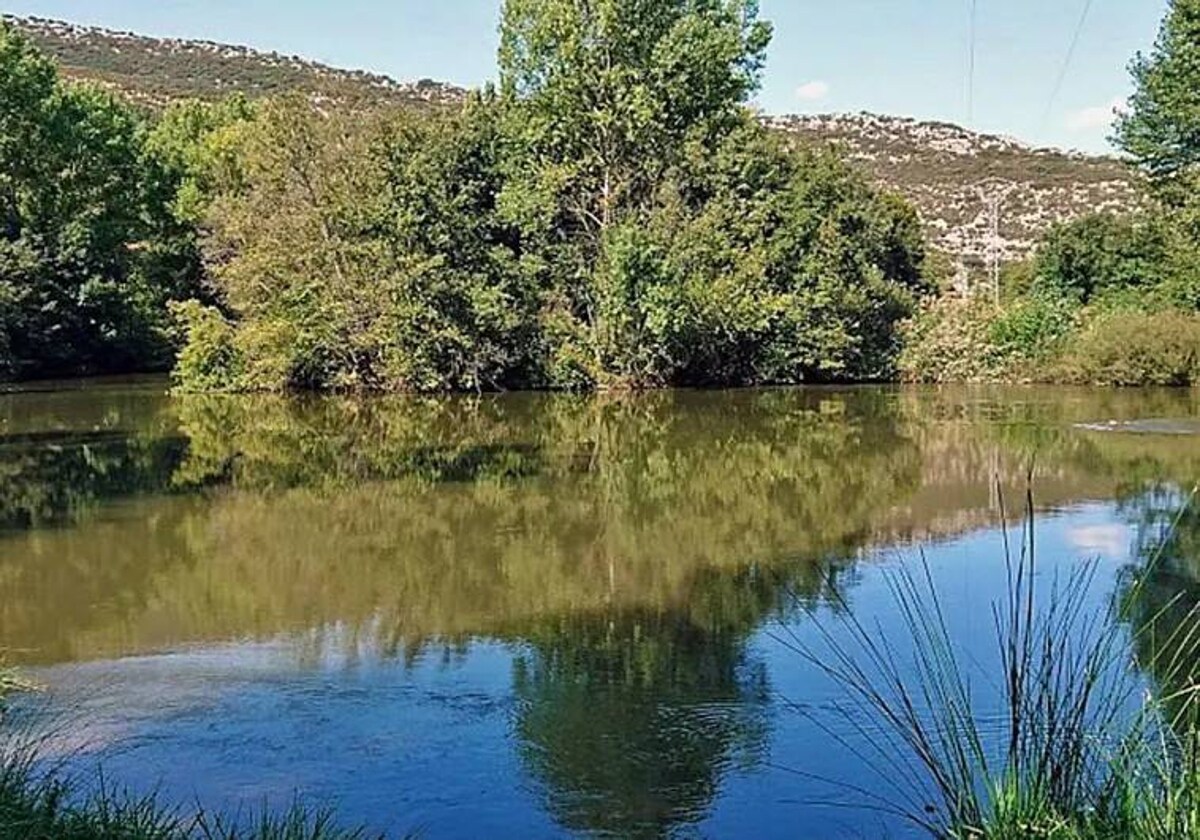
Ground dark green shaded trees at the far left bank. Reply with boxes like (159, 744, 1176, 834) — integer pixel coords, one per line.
(0, 25, 199, 377)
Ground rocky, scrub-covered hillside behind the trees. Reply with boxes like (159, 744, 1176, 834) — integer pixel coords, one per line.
(4, 16, 1138, 264)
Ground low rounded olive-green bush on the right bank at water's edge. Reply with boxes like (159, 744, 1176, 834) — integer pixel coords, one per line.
(1051, 311, 1200, 385)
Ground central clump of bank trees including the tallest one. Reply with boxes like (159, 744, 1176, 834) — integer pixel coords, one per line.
(178, 0, 924, 390)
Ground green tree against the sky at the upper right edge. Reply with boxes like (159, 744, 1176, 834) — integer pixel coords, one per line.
(1115, 0, 1200, 203)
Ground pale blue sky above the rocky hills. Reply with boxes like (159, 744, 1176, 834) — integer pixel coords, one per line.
(0, 0, 1166, 151)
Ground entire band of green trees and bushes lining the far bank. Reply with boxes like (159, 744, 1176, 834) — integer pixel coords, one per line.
(0, 0, 1200, 391)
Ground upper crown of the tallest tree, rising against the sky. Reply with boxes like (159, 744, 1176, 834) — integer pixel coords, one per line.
(499, 0, 770, 242)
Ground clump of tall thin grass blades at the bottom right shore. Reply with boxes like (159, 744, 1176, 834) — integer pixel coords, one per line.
(781, 484, 1200, 840)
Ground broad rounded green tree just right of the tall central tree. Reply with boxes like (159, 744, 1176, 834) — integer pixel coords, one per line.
(585, 116, 924, 385)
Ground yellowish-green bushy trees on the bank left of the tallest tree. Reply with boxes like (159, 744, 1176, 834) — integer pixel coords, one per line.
(176, 96, 538, 390)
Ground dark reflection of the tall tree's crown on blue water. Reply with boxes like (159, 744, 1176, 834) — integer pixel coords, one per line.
(514, 614, 768, 836)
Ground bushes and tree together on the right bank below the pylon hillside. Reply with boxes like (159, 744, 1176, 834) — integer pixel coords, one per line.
(936, 0, 1200, 393)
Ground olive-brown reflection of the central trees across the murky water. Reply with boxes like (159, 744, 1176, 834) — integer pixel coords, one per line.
(0, 395, 920, 661)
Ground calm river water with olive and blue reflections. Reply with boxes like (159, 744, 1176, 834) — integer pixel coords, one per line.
(0, 380, 1200, 839)
